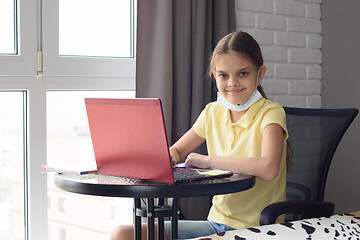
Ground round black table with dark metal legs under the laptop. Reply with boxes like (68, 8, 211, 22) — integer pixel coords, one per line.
(55, 173, 255, 240)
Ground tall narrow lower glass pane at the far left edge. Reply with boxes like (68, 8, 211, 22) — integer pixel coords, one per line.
(0, 92, 25, 240)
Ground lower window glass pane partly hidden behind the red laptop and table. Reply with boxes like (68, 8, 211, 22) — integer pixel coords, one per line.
(47, 91, 135, 240)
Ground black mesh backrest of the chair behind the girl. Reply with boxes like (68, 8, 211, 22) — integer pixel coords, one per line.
(284, 107, 358, 201)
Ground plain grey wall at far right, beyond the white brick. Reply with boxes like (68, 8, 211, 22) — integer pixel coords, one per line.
(322, 0, 360, 213)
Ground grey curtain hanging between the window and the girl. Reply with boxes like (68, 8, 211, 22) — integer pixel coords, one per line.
(136, 0, 236, 219)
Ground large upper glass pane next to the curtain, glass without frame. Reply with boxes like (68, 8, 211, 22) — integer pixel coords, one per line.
(59, 0, 131, 57)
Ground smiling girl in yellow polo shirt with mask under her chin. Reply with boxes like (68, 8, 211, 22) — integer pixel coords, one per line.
(113, 32, 287, 239)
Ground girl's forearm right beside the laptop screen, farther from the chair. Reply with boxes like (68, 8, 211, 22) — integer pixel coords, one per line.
(169, 129, 205, 165)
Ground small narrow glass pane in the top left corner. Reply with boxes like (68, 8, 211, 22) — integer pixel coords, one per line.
(0, 0, 17, 54)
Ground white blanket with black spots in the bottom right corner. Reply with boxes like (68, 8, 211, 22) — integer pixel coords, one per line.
(190, 211, 360, 240)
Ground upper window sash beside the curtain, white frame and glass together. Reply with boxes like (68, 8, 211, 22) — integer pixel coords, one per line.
(42, 0, 135, 76)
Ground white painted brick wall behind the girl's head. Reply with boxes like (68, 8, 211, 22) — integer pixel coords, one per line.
(236, 0, 322, 108)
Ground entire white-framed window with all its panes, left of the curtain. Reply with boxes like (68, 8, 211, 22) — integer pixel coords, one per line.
(0, 0, 136, 240)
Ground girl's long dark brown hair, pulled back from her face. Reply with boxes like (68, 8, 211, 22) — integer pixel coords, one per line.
(209, 31, 292, 170)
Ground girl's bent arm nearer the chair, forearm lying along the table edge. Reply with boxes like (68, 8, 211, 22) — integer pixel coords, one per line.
(185, 124, 284, 180)
